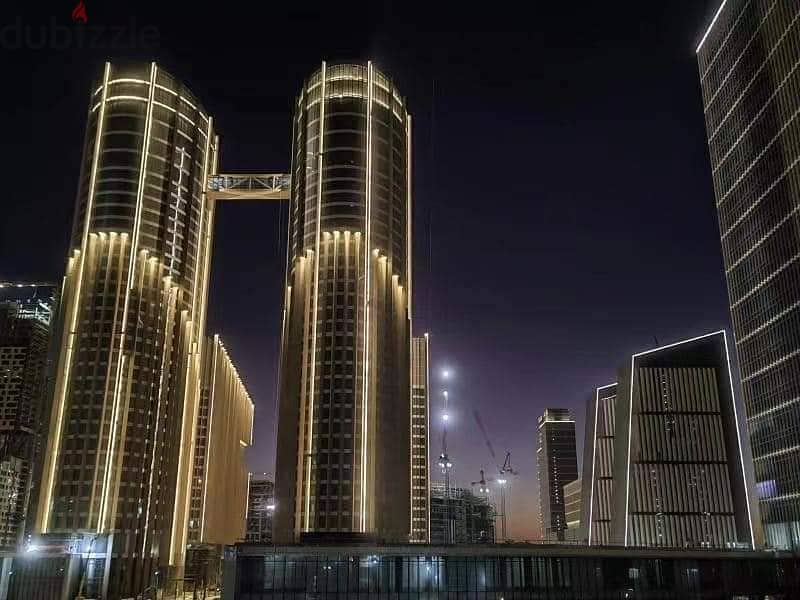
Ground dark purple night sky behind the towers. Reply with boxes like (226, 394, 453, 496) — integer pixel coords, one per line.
(0, 0, 729, 539)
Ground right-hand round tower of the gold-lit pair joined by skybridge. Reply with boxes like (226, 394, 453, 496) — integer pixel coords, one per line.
(275, 63, 411, 542)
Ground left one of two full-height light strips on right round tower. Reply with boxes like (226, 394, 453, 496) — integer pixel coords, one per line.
(304, 61, 327, 531)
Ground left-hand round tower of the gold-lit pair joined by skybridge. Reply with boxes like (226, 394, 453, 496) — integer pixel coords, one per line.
(36, 64, 217, 597)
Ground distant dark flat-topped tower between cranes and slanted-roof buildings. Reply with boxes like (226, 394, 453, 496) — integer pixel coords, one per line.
(537, 408, 578, 540)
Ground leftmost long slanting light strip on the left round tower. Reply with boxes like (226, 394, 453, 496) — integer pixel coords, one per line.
(37, 62, 111, 533)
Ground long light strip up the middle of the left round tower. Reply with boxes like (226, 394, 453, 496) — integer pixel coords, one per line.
(97, 63, 158, 533)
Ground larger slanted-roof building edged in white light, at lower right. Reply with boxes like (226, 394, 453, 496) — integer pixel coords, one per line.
(608, 331, 753, 548)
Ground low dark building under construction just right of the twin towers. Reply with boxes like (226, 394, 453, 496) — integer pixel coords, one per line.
(430, 481, 497, 544)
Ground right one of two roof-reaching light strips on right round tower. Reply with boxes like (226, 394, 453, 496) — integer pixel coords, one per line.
(361, 61, 372, 532)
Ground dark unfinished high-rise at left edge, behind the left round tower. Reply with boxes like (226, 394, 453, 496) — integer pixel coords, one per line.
(0, 283, 57, 551)
